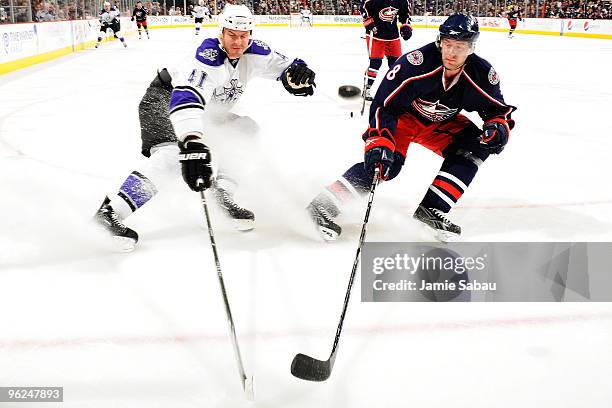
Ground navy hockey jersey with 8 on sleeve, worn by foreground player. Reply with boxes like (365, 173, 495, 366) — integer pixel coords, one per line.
(370, 43, 516, 134)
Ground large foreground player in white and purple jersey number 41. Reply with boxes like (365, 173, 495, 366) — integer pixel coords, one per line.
(95, 4, 315, 251)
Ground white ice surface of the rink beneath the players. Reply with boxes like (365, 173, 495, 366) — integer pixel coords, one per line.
(0, 28, 612, 408)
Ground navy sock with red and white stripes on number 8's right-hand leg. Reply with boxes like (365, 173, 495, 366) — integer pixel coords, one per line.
(421, 150, 482, 213)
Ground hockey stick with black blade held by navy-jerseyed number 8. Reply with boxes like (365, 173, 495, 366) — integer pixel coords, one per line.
(291, 168, 380, 381)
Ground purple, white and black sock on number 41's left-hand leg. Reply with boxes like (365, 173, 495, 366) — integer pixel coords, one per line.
(111, 171, 157, 219)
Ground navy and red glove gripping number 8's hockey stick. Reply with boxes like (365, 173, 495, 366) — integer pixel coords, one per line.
(363, 128, 395, 180)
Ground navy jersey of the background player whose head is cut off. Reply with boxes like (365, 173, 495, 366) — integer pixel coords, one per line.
(360, 0, 411, 40)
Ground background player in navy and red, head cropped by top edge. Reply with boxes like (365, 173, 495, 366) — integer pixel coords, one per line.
(361, 0, 412, 101)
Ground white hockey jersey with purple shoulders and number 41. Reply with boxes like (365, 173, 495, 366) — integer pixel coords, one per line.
(170, 38, 293, 141)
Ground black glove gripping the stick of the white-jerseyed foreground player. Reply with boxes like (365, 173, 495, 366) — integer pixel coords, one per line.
(179, 139, 212, 191)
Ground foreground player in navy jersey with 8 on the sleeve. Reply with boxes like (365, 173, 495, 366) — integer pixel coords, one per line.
(308, 13, 516, 241)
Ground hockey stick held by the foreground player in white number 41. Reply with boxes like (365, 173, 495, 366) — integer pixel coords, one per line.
(198, 179, 255, 401)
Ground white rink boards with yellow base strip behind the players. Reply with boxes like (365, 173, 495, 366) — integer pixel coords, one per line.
(0, 15, 612, 75)
